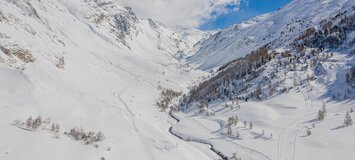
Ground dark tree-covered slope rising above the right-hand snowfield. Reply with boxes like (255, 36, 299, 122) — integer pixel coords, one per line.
(186, 2, 355, 107)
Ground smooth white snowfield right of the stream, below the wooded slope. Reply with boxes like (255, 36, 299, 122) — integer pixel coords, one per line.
(173, 88, 355, 160)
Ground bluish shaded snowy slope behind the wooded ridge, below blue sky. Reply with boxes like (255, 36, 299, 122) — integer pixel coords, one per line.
(188, 0, 352, 70)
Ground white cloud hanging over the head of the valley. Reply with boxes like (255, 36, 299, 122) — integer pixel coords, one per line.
(119, 0, 240, 27)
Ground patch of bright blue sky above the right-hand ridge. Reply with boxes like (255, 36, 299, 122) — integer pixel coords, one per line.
(199, 0, 291, 30)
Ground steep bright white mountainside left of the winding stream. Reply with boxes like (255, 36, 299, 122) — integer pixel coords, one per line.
(0, 0, 216, 160)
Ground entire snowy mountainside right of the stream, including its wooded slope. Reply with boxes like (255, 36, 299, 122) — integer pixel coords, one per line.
(177, 0, 355, 160)
